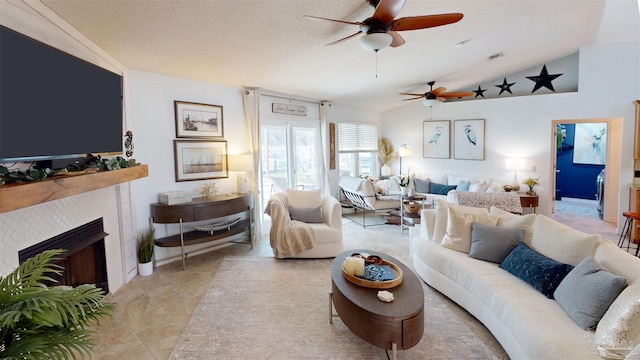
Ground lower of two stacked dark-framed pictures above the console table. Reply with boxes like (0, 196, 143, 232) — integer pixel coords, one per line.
(173, 140, 229, 181)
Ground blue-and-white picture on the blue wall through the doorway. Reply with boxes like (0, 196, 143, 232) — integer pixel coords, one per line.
(573, 123, 607, 165)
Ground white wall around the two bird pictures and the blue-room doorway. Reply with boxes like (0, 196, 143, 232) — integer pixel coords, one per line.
(381, 43, 640, 224)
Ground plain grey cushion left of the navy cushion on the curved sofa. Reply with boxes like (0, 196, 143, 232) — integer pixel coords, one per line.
(469, 222, 525, 264)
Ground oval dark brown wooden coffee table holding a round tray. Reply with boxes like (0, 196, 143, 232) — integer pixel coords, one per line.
(329, 249, 424, 359)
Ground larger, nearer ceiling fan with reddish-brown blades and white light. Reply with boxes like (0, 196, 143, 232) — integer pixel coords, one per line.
(305, 0, 463, 52)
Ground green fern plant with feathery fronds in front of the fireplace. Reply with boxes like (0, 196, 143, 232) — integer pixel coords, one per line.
(0, 249, 116, 359)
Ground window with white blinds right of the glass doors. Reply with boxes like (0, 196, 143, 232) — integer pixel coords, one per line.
(338, 123, 378, 176)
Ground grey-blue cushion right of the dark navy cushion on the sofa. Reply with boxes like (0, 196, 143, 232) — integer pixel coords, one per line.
(553, 256, 627, 330)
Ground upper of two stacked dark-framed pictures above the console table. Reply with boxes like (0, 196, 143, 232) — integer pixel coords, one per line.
(173, 101, 224, 139)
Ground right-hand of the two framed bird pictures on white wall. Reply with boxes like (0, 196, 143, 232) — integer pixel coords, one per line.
(453, 119, 484, 160)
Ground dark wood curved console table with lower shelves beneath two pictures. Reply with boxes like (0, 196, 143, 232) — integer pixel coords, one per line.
(150, 193, 253, 269)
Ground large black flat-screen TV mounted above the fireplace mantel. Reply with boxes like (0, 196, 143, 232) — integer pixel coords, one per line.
(0, 26, 124, 162)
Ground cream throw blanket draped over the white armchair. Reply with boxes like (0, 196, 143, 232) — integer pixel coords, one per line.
(264, 193, 315, 258)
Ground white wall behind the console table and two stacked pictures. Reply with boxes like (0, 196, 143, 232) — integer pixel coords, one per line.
(128, 71, 249, 260)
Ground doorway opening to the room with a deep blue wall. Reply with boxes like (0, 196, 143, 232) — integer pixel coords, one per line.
(551, 118, 622, 224)
